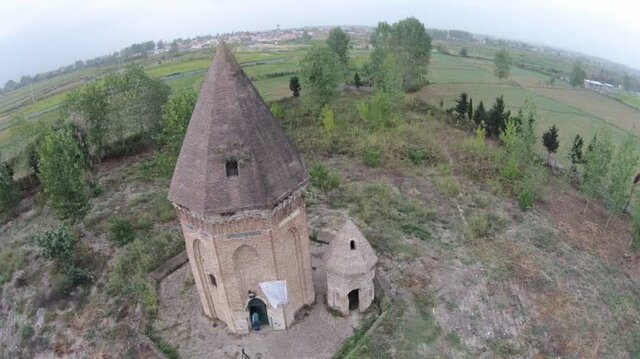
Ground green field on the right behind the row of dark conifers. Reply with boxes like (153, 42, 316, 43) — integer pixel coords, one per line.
(417, 54, 640, 163)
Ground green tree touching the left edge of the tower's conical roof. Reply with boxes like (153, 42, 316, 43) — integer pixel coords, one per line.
(160, 89, 198, 155)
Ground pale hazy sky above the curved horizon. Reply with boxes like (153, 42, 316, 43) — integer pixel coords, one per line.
(0, 0, 640, 85)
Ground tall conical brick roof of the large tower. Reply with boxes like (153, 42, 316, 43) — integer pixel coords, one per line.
(169, 44, 307, 215)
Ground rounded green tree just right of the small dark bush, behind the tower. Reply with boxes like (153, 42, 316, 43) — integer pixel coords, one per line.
(300, 45, 342, 111)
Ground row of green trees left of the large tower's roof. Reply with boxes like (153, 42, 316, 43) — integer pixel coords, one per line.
(0, 67, 190, 219)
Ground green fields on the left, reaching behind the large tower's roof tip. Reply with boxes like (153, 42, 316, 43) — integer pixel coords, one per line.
(0, 49, 305, 156)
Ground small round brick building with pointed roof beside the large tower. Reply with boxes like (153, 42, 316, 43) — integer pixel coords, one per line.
(325, 219, 378, 315)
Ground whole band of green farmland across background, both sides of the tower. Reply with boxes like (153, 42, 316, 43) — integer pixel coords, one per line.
(0, 45, 640, 167)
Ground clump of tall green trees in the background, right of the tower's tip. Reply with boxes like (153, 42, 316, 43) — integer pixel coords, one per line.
(298, 18, 431, 122)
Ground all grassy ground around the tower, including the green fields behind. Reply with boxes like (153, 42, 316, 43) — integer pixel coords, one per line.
(0, 35, 640, 358)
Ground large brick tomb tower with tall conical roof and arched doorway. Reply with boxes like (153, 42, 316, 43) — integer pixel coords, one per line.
(169, 44, 315, 334)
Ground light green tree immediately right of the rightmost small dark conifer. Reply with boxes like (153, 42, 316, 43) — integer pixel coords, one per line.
(582, 127, 614, 204)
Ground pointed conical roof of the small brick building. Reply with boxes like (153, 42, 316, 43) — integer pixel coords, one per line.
(325, 219, 378, 276)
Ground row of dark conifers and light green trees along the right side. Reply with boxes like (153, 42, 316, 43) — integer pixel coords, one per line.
(449, 93, 640, 238)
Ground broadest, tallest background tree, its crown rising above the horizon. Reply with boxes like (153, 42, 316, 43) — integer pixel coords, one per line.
(369, 17, 431, 91)
